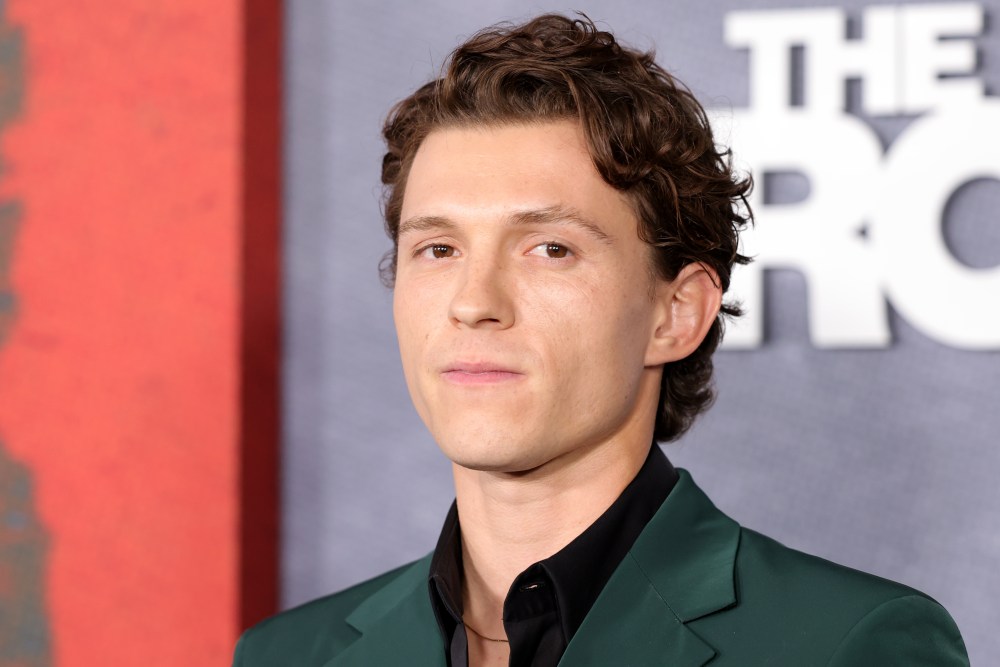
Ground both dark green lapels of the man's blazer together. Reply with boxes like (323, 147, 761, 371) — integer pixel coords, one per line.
(324, 469, 740, 667)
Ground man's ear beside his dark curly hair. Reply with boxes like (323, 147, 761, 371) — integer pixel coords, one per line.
(646, 264, 722, 366)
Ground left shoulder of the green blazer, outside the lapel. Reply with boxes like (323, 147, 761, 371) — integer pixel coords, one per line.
(233, 558, 428, 667)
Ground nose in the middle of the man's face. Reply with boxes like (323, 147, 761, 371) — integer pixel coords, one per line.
(448, 257, 514, 329)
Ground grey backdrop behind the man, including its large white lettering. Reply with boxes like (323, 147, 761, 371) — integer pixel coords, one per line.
(282, 0, 1000, 664)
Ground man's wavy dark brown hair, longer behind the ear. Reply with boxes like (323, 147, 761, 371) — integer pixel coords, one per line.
(381, 14, 752, 442)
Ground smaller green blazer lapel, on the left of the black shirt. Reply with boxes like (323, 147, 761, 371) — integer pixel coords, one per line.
(324, 557, 445, 667)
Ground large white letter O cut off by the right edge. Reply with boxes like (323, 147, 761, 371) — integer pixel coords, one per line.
(872, 100, 1000, 350)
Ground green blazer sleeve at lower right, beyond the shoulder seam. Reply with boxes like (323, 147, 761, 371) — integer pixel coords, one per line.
(828, 595, 969, 667)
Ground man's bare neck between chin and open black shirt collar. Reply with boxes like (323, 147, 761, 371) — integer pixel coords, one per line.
(453, 433, 652, 637)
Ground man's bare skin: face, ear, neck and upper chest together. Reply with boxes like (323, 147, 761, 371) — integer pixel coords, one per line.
(393, 120, 722, 665)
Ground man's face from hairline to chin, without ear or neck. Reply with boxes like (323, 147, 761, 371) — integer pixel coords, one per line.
(393, 121, 664, 472)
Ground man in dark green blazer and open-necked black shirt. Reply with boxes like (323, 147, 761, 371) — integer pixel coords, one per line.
(235, 15, 968, 667)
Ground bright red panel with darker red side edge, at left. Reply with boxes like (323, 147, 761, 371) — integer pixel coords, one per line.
(0, 0, 280, 667)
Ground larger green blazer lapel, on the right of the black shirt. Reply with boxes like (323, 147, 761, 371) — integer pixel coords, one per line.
(560, 470, 739, 667)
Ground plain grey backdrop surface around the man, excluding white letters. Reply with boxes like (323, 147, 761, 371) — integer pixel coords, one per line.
(283, 0, 1000, 664)
